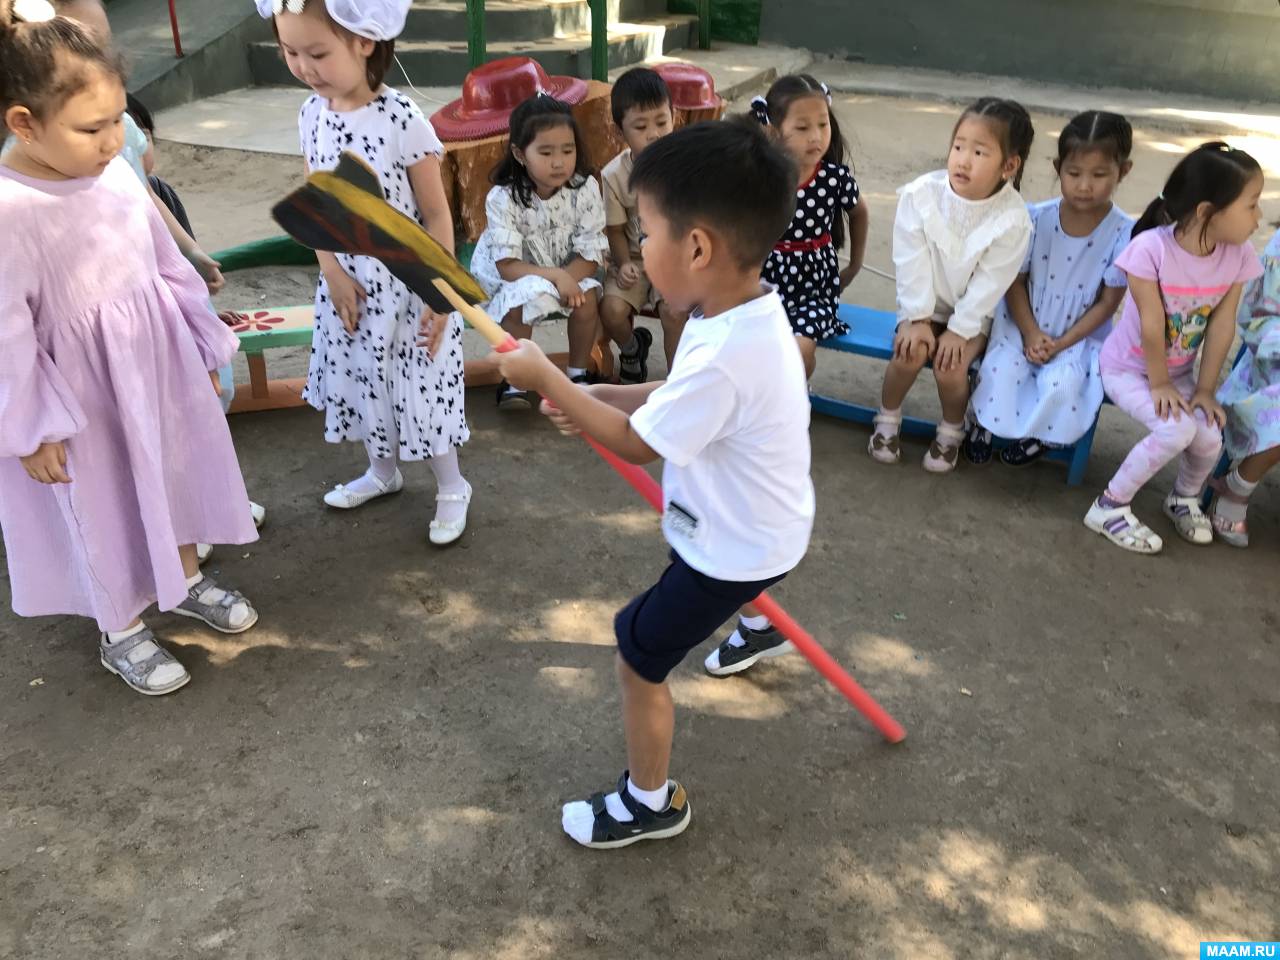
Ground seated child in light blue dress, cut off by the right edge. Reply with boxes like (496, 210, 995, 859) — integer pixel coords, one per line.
(1210, 232, 1280, 547)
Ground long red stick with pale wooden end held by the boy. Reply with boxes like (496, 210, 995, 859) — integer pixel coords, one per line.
(435, 280, 906, 744)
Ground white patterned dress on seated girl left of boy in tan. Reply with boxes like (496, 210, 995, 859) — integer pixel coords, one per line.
(471, 177, 609, 324)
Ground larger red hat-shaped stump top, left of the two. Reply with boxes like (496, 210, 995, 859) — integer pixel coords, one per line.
(431, 56, 586, 141)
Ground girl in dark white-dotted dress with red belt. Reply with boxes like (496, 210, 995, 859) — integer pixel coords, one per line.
(751, 73, 868, 376)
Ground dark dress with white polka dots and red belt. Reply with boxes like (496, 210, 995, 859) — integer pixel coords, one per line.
(763, 160, 859, 340)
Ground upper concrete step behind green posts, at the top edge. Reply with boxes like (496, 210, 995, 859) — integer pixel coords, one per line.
(402, 0, 667, 44)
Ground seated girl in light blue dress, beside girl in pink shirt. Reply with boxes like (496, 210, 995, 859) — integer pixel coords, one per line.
(965, 110, 1133, 466)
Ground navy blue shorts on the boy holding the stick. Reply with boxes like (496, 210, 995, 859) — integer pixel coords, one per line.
(613, 552, 786, 684)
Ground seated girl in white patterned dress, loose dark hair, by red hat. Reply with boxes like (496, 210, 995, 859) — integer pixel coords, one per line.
(471, 93, 609, 408)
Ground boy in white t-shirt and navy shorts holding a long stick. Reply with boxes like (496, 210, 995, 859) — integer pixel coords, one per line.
(494, 120, 814, 847)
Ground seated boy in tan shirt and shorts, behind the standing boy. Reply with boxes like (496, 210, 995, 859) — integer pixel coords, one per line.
(600, 67, 689, 383)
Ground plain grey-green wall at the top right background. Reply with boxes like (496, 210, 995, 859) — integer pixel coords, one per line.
(757, 0, 1280, 101)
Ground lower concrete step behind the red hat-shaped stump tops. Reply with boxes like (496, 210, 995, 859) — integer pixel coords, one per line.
(248, 14, 698, 87)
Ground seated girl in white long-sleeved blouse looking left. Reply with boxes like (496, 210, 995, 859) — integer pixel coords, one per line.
(868, 97, 1034, 474)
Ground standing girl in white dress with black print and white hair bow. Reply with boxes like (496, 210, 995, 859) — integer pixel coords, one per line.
(257, 0, 471, 545)
